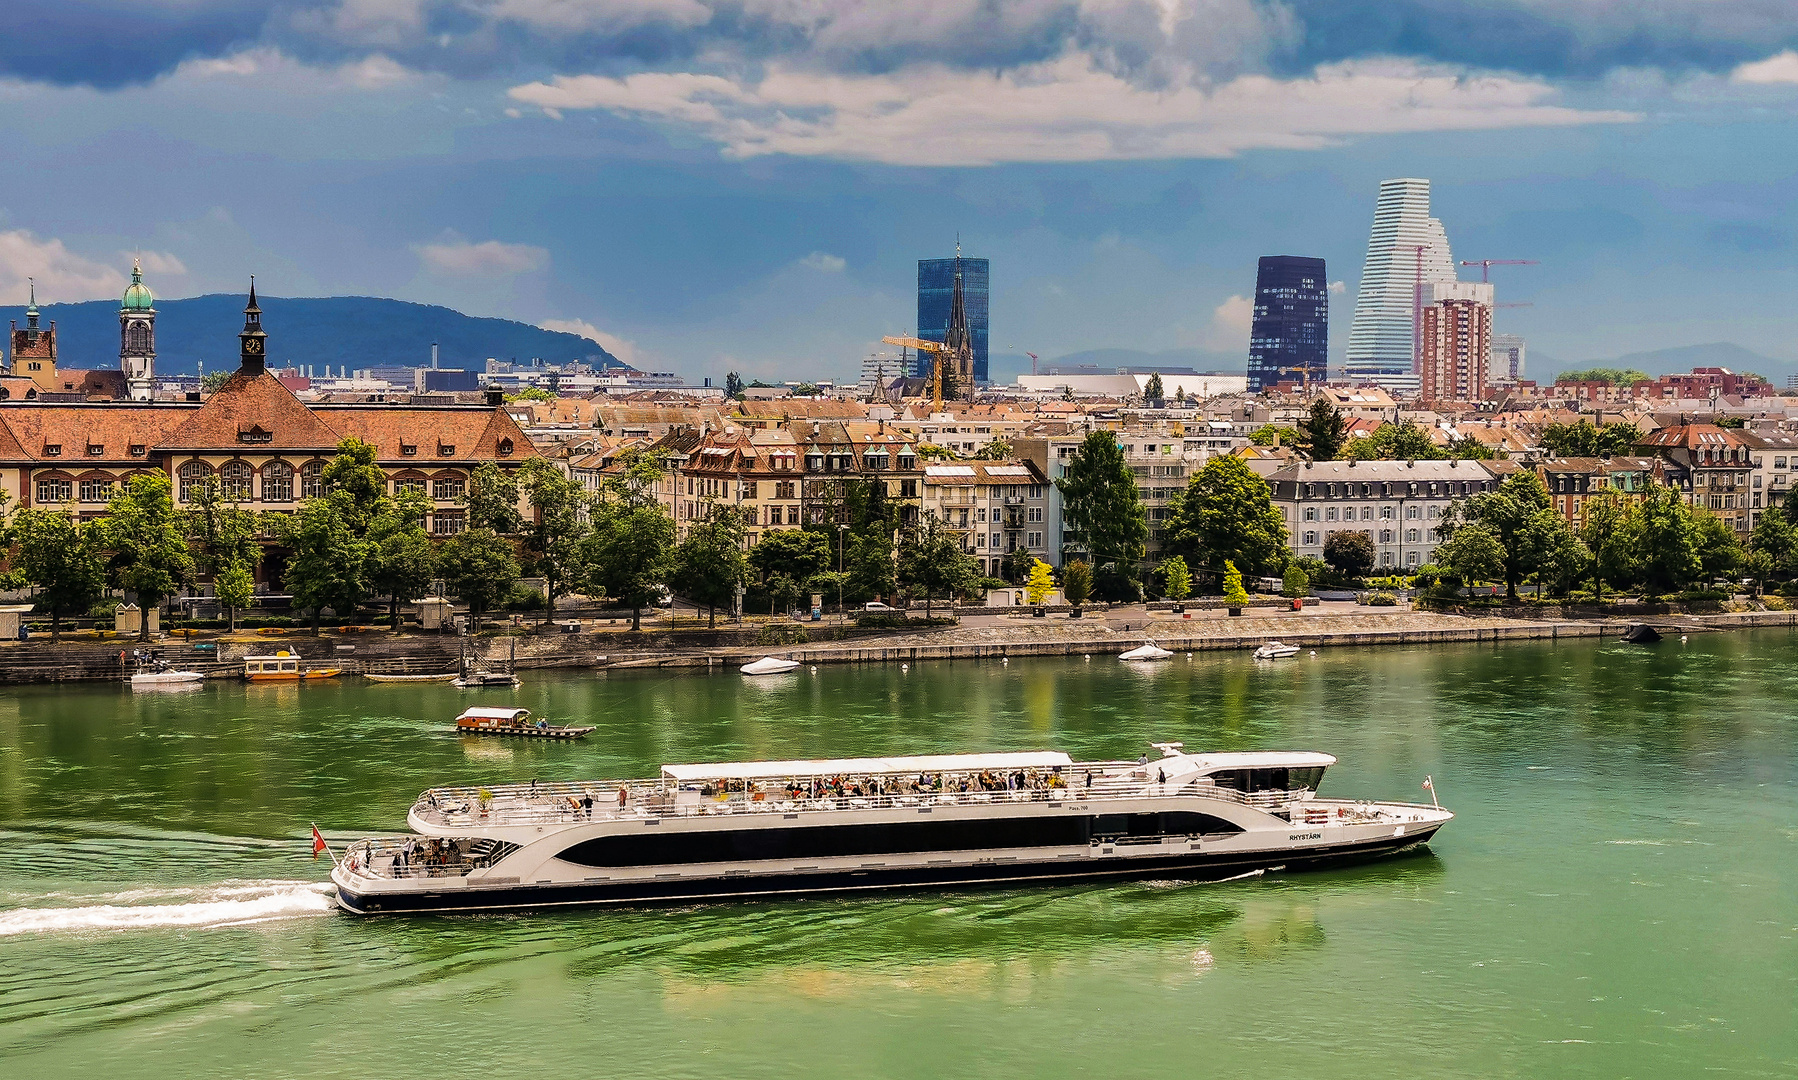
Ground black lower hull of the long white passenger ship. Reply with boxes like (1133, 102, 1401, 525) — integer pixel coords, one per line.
(336, 823, 1442, 915)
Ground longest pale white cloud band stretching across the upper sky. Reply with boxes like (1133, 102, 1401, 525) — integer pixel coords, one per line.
(511, 54, 1638, 165)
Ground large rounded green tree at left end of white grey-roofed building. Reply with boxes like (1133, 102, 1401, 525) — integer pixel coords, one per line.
(1163, 455, 1289, 577)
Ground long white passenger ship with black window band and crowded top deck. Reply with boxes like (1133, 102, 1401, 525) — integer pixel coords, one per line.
(331, 742, 1453, 915)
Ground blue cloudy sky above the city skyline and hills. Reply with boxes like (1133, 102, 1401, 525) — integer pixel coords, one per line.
(0, 0, 1798, 379)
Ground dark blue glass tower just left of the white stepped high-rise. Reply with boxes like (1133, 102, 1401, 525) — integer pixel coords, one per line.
(1248, 255, 1331, 394)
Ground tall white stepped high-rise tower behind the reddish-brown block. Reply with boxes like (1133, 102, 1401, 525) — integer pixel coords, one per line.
(1345, 178, 1455, 394)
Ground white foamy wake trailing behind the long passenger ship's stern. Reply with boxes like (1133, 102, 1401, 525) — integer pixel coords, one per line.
(0, 881, 334, 938)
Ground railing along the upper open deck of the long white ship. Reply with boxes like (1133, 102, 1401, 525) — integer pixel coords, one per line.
(412, 776, 1314, 828)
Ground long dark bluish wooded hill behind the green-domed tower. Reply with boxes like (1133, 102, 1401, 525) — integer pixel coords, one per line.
(0, 295, 624, 376)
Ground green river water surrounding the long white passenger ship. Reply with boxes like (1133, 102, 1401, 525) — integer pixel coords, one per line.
(0, 631, 1798, 1080)
